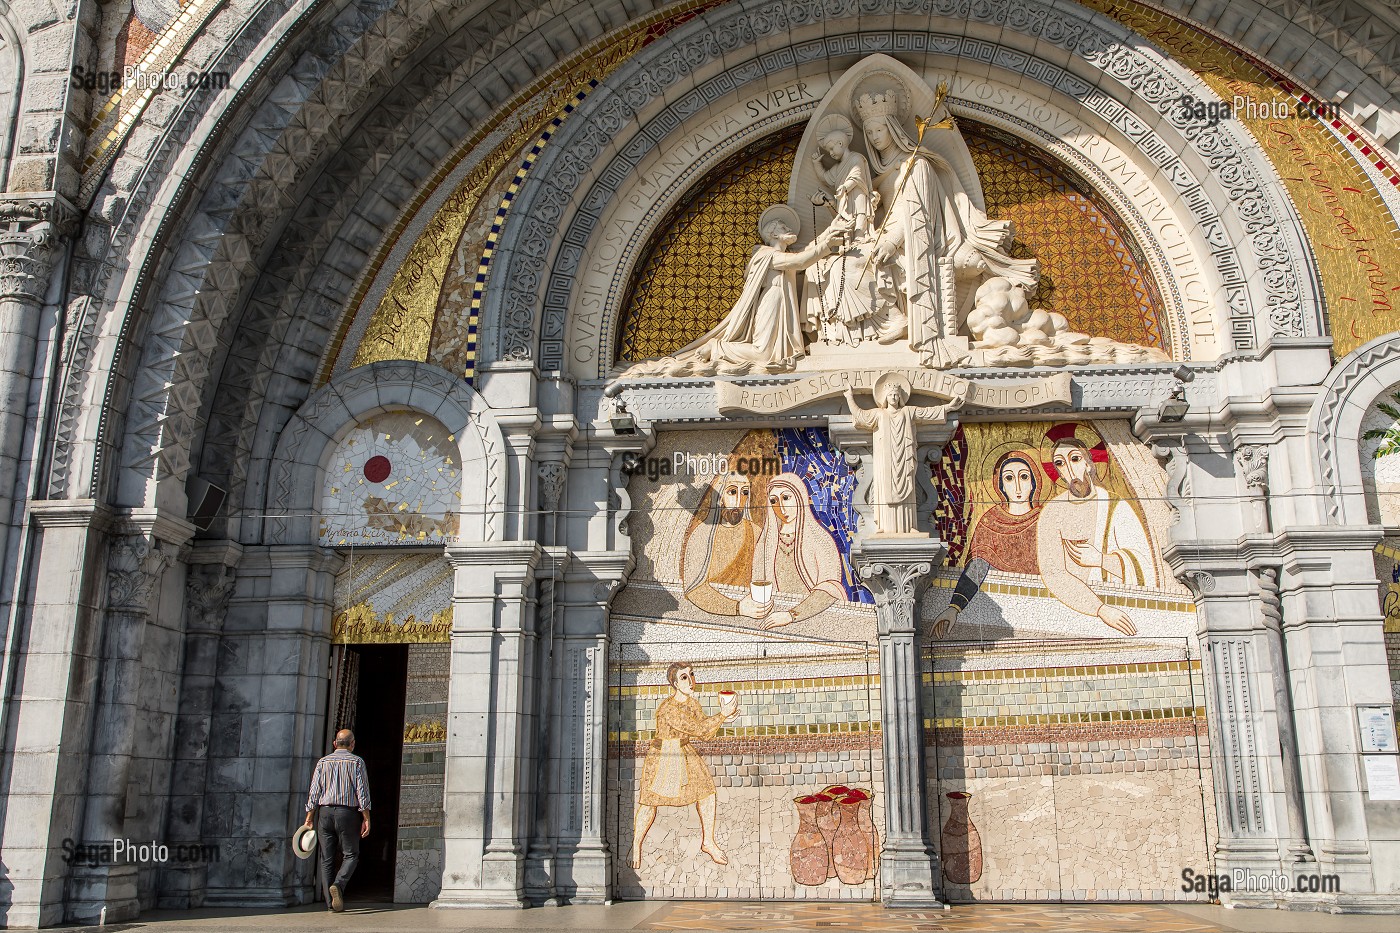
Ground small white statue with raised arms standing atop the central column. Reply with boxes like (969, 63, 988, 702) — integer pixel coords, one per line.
(846, 373, 963, 535)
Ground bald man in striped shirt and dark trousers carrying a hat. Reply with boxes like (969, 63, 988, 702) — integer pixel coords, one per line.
(307, 728, 370, 911)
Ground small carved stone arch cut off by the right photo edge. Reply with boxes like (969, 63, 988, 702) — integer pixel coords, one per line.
(1308, 335, 1400, 525)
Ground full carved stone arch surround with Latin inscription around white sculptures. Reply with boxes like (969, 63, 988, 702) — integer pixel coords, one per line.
(480, 0, 1322, 378)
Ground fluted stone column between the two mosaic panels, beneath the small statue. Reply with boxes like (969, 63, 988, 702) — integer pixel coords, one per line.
(851, 537, 946, 908)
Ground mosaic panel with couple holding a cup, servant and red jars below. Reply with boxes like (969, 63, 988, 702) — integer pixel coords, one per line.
(609, 430, 885, 899)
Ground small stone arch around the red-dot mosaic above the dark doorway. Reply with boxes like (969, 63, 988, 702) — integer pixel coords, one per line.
(260, 355, 508, 545)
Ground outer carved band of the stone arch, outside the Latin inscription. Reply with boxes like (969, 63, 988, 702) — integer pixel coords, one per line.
(482, 0, 1323, 370)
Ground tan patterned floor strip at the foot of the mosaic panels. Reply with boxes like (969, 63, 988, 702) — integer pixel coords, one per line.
(636, 904, 1228, 933)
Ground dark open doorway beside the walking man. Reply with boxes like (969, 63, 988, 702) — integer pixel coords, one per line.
(340, 644, 409, 901)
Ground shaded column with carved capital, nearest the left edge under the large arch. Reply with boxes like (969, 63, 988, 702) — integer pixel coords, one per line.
(69, 534, 175, 922)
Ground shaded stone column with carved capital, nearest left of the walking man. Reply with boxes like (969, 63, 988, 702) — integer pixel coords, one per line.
(157, 541, 242, 909)
